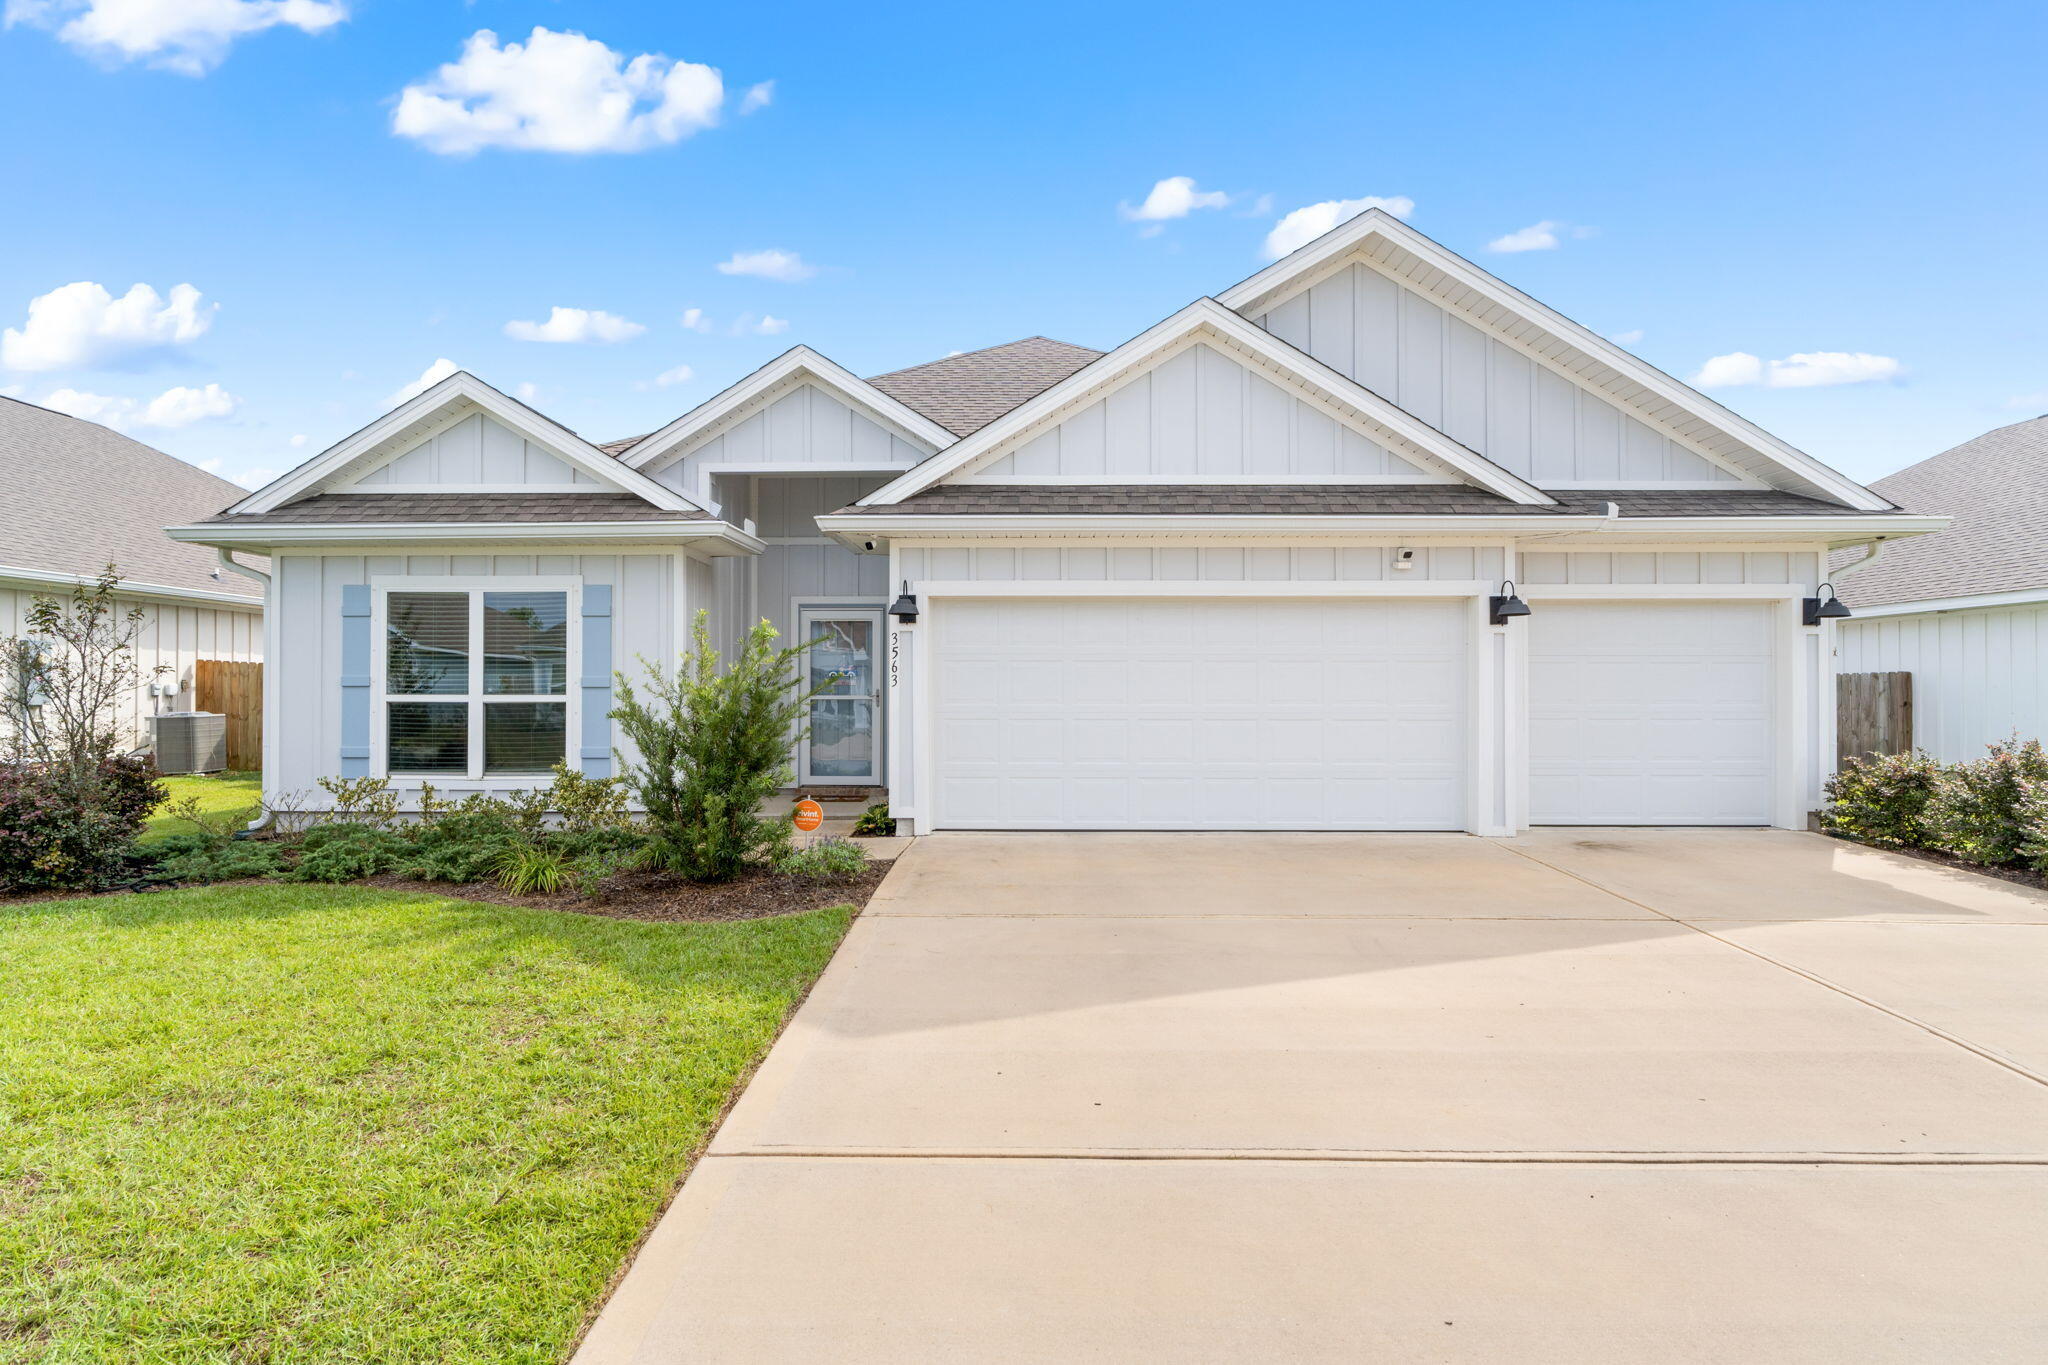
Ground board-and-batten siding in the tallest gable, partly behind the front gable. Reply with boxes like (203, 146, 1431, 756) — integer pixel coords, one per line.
(1251, 262, 1741, 487)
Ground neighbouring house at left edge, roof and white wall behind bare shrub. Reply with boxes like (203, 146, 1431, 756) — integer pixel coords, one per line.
(0, 397, 262, 745)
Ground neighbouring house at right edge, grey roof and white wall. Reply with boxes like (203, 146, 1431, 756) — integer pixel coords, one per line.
(1835, 417, 2048, 763)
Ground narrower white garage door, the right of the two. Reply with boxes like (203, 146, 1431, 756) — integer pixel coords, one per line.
(1526, 600, 1776, 825)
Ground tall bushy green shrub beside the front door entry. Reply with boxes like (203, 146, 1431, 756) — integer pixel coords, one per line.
(612, 612, 817, 882)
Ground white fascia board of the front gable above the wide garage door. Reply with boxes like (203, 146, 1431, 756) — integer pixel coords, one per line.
(860, 299, 1556, 508)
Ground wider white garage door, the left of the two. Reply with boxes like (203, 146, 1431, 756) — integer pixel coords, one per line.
(930, 598, 1470, 829)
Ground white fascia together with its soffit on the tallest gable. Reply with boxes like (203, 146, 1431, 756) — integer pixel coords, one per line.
(1219, 209, 1890, 512)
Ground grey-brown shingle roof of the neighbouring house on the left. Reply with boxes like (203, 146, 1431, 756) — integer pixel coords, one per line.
(0, 399, 262, 600)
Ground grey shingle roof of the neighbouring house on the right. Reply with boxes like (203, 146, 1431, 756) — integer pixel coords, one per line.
(1839, 415, 2048, 608)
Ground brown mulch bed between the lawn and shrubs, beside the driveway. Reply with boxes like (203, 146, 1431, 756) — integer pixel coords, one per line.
(358, 862, 891, 925)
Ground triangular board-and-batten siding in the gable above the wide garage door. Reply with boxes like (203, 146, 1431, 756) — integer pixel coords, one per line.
(971, 344, 1440, 483)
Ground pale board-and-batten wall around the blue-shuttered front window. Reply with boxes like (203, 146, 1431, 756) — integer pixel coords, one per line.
(264, 553, 684, 810)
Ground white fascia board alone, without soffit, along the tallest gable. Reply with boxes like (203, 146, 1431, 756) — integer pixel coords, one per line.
(1219, 209, 1892, 512)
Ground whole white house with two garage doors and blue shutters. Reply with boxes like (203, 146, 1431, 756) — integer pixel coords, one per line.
(170, 211, 1944, 833)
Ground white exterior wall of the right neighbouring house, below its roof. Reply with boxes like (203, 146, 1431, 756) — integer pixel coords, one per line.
(1835, 604, 2048, 763)
